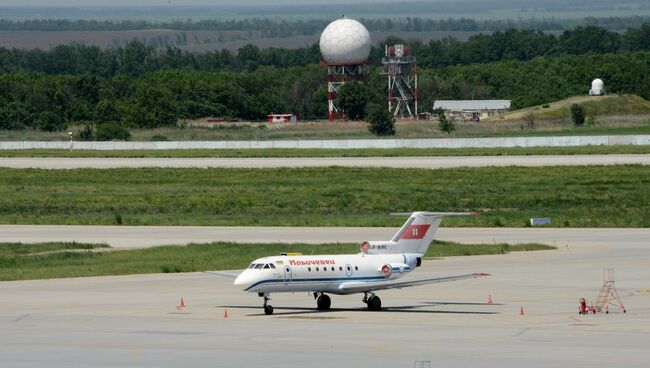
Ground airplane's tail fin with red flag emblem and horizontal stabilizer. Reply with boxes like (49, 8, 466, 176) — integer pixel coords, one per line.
(367, 212, 474, 254)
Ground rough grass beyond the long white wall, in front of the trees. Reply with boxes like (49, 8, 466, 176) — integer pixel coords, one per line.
(0, 110, 650, 141)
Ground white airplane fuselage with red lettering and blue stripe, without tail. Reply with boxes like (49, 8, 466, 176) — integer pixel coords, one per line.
(235, 253, 421, 294)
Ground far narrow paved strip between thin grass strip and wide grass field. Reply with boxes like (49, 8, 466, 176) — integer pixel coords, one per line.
(0, 154, 650, 169)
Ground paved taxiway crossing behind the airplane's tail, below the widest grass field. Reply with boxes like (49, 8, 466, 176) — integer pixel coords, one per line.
(0, 225, 650, 247)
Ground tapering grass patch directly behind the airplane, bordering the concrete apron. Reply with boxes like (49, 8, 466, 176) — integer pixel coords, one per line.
(0, 242, 554, 281)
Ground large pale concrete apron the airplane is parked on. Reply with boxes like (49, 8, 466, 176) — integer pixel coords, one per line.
(0, 228, 650, 368)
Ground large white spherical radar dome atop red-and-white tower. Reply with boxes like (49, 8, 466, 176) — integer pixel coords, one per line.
(320, 18, 371, 65)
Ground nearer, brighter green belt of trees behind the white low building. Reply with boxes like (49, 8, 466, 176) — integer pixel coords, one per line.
(0, 51, 650, 130)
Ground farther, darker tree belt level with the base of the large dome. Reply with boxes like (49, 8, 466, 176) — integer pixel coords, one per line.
(0, 23, 650, 78)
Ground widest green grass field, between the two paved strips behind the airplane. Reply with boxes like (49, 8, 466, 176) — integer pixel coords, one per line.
(0, 165, 650, 227)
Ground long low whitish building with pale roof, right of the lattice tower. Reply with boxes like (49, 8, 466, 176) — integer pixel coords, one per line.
(433, 100, 511, 121)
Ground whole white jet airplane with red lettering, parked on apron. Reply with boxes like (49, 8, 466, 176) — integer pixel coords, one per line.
(225, 212, 489, 314)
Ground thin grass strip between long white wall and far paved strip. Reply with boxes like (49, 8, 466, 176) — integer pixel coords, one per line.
(0, 146, 650, 158)
